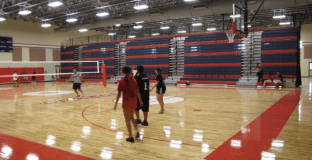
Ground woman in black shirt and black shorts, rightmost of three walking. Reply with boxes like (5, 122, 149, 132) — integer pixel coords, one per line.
(151, 68, 166, 114)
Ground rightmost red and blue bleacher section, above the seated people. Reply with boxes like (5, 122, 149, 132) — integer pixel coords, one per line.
(261, 28, 299, 78)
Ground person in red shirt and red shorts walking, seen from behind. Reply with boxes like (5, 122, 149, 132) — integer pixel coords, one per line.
(114, 66, 143, 142)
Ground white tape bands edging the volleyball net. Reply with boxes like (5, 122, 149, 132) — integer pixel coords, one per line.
(0, 61, 100, 78)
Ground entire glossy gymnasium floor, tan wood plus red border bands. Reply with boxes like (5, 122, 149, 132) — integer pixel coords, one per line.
(0, 79, 312, 160)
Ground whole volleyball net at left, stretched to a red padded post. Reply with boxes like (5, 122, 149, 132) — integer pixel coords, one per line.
(0, 61, 107, 86)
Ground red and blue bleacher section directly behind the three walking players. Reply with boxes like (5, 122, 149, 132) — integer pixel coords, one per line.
(126, 38, 171, 80)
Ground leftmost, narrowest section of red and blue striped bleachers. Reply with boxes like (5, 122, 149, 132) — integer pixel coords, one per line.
(60, 46, 77, 80)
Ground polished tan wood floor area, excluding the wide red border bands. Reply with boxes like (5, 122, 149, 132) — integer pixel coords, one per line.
(0, 79, 312, 160)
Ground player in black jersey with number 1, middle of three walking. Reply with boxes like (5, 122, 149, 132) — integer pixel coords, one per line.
(134, 65, 149, 126)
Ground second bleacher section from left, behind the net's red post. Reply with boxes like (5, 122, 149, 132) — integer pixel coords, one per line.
(82, 42, 116, 81)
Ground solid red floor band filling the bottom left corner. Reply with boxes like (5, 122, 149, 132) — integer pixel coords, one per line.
(0, 133, 93, 160)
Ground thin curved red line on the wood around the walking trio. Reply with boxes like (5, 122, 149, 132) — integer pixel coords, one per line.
(81, 101, 206, 149)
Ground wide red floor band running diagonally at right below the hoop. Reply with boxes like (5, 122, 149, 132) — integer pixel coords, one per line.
(205, 90, 301, 160)
